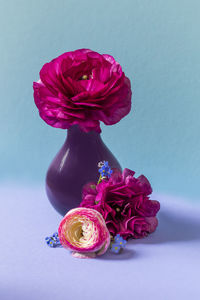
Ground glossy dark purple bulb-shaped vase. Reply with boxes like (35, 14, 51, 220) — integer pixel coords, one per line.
(46, 125, 121, 215)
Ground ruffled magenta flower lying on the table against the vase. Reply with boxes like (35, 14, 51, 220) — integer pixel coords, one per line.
(80, 169, 160, 239)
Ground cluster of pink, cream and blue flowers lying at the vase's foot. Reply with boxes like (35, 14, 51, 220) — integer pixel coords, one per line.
(46, 161, 160, 258)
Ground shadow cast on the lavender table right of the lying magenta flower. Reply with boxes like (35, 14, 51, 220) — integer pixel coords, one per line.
(129, 211, 200, 244)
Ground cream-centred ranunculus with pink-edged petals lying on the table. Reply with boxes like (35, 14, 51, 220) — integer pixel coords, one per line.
(58, 207, 110, 258)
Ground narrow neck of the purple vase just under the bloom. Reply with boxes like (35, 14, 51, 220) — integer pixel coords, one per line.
(67, 125, 101, 141)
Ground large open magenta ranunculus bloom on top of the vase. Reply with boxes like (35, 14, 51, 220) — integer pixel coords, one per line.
(33, 49, 131, 132)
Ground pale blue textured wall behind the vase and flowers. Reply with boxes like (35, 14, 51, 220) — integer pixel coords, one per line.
(0, 0, 200, 201)
